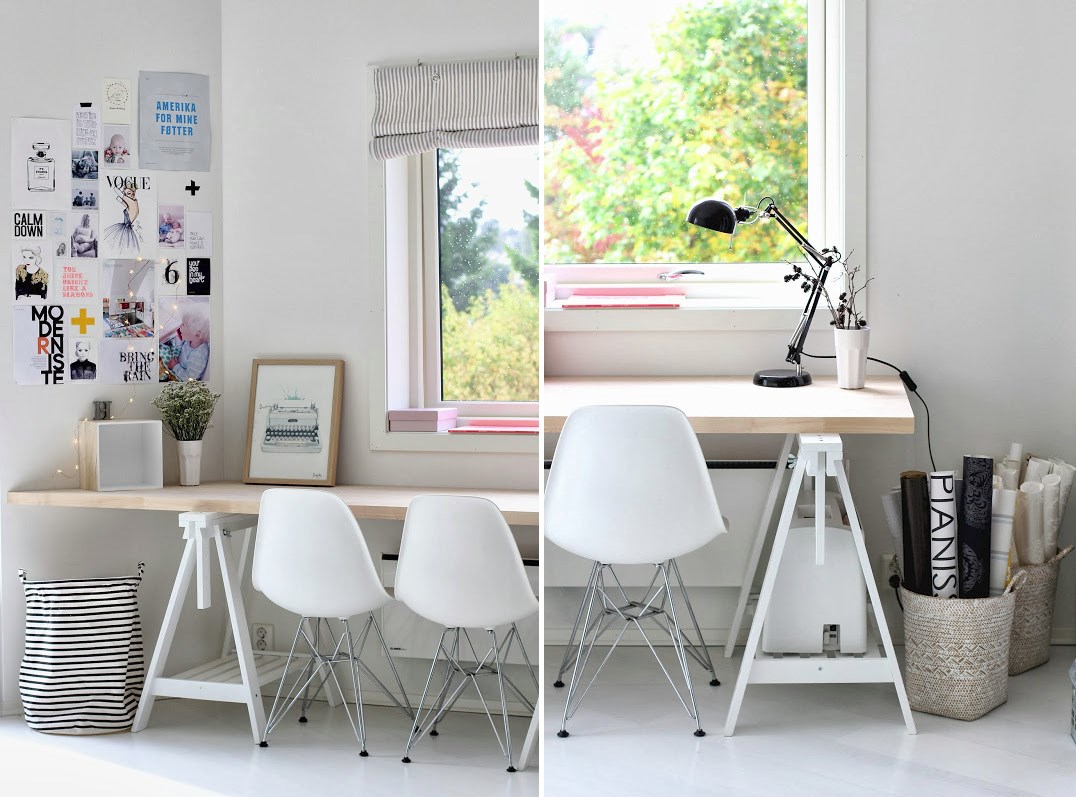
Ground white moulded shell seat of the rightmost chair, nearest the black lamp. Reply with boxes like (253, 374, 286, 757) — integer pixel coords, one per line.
(543, 405, 725, 565)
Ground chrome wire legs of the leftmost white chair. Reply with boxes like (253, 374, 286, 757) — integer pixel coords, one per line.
(259, 612, 414, 757)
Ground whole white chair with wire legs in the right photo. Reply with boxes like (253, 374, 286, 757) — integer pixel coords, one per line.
(543, 405, 726, 738)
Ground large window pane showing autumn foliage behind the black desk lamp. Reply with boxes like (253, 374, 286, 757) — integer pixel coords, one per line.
(542, 0, 807, 264)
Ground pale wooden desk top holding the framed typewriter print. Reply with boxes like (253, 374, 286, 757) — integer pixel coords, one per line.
(1, 482, 538, 526)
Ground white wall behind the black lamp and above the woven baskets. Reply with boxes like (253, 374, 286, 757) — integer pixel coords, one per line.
(546, 0, 1076, 643)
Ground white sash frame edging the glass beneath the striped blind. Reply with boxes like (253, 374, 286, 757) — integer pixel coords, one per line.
(413, 152, 538, 417)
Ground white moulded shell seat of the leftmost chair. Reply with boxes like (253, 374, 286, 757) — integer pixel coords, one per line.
(252, 487, 392, 617)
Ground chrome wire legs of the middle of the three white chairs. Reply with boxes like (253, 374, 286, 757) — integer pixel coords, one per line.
(402, 623, 538, 772)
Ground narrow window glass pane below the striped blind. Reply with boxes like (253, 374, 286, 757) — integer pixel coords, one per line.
(437, 146, 538, 401)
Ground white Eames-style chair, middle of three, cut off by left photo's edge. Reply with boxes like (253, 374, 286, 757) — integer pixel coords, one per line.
(396, 495, 538, 772)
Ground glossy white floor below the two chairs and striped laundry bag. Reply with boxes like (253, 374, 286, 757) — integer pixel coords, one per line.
(0, 699, 538, 797)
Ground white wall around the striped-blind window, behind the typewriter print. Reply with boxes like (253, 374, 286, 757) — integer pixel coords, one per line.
(217, 0, 539, 709)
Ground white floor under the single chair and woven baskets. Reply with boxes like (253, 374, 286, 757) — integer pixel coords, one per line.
(542, 647, 1076, 797)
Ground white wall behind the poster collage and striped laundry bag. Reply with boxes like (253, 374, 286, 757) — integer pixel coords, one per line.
(0, 0, 225, 711)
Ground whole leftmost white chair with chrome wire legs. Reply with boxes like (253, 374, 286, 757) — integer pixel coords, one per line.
(252, 488, 414, 756)
